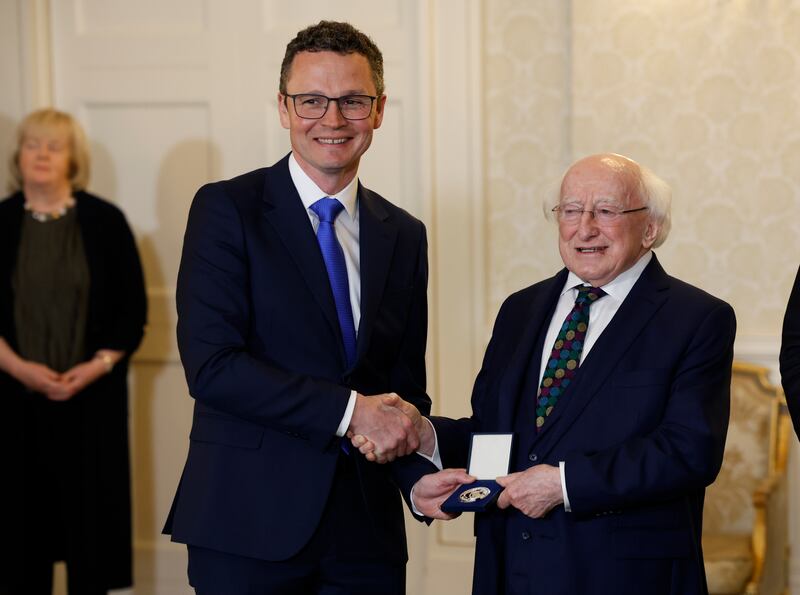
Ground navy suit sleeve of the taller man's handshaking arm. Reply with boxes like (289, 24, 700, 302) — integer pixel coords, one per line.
(177, 184, 350, 449)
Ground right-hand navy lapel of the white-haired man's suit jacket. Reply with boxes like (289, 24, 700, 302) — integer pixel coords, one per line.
(538, 254, 669, 448)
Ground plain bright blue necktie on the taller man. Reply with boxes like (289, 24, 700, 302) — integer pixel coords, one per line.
(311, 198, 356, 367)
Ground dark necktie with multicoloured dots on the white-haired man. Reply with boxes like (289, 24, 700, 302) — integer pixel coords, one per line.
(536, 285, 606, 432)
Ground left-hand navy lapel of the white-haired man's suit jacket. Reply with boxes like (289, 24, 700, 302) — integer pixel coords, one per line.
(498, 269, 567, 431)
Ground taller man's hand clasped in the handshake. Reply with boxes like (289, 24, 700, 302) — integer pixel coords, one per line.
(347, 393, 419, 463)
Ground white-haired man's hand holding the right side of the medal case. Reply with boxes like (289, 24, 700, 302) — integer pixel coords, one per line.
(497, 465, 564, 519)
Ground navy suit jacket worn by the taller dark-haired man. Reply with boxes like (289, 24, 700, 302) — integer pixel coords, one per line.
(165, 156, 430, 560)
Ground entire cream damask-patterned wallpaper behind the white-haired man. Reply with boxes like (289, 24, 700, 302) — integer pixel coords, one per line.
(484, 0, 800, 345)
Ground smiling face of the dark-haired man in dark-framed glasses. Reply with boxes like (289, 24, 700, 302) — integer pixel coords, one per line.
(278, 52, 386, 194)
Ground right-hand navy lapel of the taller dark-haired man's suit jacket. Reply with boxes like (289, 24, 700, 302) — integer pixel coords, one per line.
(356, 184, 397, 360)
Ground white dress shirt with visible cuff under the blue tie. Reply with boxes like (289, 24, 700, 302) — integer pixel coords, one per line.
(289, 153, 361, 436)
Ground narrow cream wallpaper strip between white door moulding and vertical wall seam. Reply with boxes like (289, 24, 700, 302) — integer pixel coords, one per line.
(484, 0, 572, 308)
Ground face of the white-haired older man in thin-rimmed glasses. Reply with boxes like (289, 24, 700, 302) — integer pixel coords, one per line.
(558, 155, 658, 287)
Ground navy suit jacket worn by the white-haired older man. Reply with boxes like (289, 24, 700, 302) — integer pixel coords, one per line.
(422, 257, 735, 595)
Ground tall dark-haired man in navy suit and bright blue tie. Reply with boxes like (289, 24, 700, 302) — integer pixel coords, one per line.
(165, 21, 430, 595)
